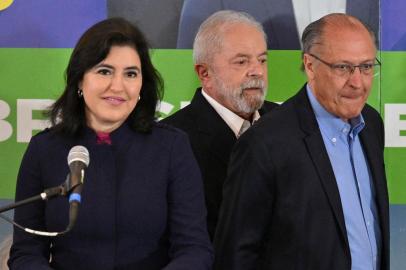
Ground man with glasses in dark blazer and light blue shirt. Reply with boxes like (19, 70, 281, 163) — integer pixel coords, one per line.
(214, 13, 389, 270)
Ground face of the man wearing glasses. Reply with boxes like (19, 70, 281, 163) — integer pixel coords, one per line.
(303, 20, 376, 121)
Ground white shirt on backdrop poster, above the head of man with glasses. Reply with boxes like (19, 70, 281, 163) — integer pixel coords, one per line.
(292, 0, 347, 41)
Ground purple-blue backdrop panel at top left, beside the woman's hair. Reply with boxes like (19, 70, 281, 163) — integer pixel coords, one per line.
(0, 0, 107, 48)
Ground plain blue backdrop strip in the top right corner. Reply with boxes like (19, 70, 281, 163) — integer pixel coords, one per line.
(381, 0, 406, 51)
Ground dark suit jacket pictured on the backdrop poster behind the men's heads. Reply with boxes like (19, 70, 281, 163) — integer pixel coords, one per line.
(177, 0, 379, 50)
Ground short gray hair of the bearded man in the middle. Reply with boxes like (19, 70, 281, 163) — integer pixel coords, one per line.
(193, 10, 266, 64)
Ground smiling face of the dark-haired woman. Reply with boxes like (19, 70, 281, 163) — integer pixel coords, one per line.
(79, 46, 142, 132)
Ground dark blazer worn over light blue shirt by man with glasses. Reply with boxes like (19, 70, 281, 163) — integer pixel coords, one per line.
(214, 87, 389, 270)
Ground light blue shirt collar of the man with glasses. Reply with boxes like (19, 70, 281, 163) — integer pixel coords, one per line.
(306, 84, 365, 140)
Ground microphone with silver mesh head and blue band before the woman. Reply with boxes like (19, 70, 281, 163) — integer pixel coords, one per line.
(65, 145, 90, 232)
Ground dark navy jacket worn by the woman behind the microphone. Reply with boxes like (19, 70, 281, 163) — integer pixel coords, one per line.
(9, 124, 212, 270)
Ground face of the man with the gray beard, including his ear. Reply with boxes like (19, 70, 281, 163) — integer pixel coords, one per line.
(195, 23, 268, 119)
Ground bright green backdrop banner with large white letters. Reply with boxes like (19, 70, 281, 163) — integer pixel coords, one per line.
(0, 48, 406, 204)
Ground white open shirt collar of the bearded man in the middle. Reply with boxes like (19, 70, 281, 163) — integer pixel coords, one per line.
(202, 89, 260, 137)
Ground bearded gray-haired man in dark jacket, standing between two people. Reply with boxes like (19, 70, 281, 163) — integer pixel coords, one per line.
(163, 10, 277, 239)
